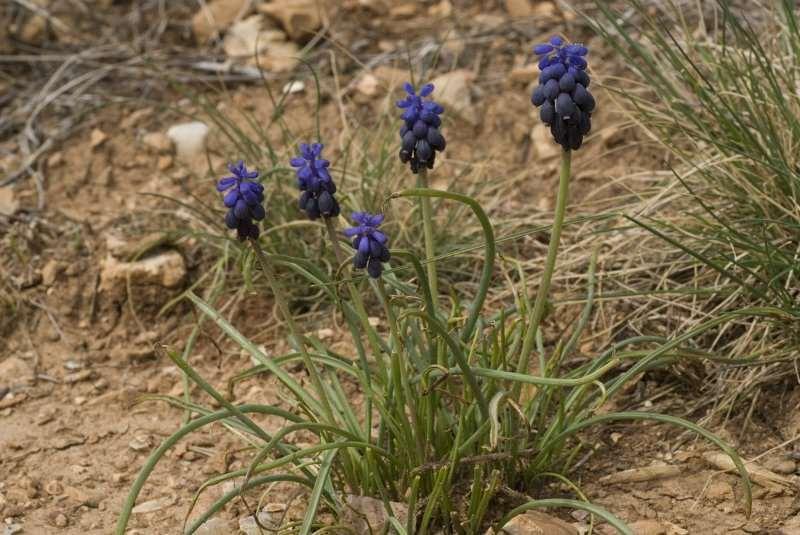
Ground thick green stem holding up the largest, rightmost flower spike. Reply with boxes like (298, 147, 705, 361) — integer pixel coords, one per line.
(514, 150, 572, 390)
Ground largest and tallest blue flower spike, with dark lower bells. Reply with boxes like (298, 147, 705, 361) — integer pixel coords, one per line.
(531, 35, 595, 150)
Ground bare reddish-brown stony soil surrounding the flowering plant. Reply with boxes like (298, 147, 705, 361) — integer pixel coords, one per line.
(0, 0, 800, 535)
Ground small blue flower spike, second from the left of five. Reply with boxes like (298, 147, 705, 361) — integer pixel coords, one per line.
(289, 143, 340, 219)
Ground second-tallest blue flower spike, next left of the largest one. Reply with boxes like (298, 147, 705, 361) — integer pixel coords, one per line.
(397, 82, 447, 173)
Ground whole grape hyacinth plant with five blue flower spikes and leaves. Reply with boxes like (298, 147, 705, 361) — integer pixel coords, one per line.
(115, 38, 750, 535)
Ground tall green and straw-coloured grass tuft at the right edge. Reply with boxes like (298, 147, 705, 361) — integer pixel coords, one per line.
(593, 0, 800, 420)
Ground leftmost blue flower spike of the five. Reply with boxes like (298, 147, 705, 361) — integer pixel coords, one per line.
(217, 161, 267, 241)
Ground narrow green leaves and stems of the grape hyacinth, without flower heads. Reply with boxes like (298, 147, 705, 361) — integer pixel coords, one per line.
(116, 46, 750, 535)
